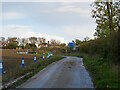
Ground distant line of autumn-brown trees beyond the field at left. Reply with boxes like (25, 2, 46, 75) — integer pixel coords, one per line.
(0, 37, 60, 49)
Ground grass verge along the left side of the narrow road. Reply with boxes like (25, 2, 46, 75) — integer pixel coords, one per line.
(3, 56, 64, 90)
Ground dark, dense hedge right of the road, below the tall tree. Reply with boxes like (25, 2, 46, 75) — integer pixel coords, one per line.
(79, 32, 118, 63)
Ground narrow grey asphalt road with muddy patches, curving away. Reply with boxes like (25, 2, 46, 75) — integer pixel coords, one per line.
(18, 56, 94, 88)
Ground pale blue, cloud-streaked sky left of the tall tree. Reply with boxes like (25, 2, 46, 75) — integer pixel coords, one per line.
(0, 2, 96, 43)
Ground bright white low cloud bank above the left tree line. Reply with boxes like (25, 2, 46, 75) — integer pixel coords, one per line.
(2, 25, 67, 43)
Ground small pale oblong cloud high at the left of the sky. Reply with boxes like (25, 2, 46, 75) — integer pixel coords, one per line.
(3, 12, 26, 20)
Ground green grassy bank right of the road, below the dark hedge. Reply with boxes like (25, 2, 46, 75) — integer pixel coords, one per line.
(69, 54, 119, 88)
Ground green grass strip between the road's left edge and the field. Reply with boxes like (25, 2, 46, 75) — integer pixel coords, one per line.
(2, 56, 63, 88)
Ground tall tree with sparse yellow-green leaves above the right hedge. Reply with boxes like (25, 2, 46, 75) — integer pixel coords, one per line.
(91, 0, 119, 37)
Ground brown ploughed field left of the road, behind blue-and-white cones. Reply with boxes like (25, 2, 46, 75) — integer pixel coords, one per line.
(2, 49, 42, 84)
